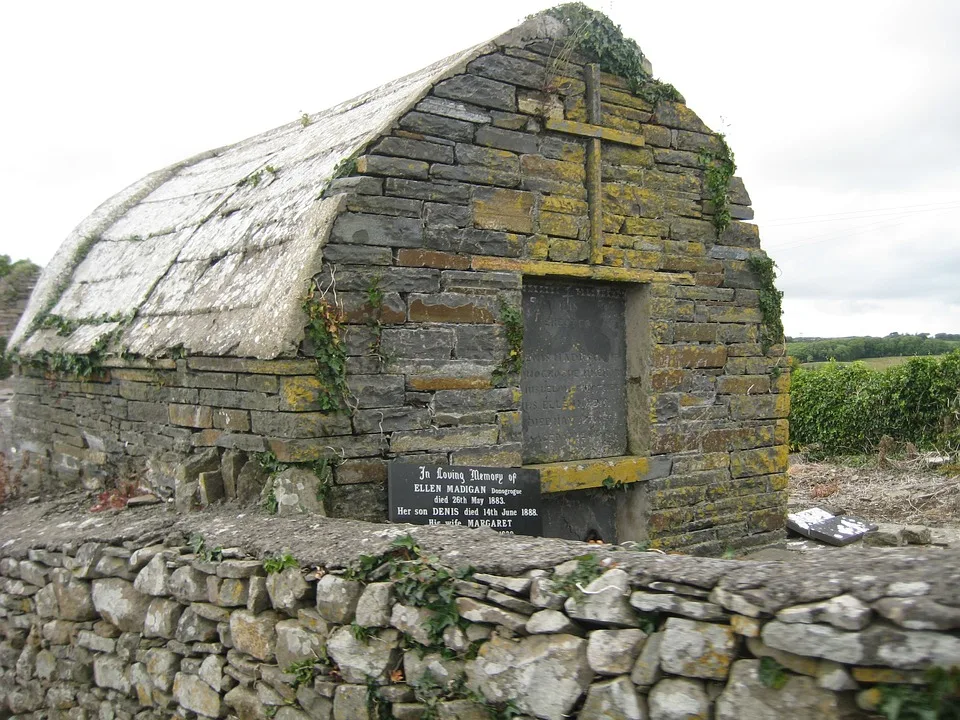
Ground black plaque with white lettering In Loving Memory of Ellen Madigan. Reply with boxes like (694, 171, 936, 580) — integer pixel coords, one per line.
(387, 462, 543, 535)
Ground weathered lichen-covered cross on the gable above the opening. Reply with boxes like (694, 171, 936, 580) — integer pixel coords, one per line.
(546, 63, 644, 265)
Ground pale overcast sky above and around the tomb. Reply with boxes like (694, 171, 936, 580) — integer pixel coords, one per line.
(0, 0, 960, 336)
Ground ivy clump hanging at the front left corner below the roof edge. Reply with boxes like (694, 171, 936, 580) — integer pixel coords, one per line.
(301, 281, 349, 412)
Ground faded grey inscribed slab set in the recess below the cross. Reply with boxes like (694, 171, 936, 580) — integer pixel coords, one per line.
(520, 281, 627, 463)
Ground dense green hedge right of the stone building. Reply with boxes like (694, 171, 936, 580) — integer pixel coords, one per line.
(790, 350, 960, 454)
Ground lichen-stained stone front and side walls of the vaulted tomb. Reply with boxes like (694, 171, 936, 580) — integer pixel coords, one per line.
(9, 38, 789, 554)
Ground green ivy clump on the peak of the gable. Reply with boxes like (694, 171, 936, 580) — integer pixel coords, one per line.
(545, 2, 684, 103)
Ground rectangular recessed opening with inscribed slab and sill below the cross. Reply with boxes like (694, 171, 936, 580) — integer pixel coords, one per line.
(520, 278, 651, 541)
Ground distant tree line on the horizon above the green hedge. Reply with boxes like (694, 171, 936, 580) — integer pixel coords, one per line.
(787, 333, 960, 363)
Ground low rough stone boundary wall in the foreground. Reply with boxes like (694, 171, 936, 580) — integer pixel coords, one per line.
(0, 506, 960, 720)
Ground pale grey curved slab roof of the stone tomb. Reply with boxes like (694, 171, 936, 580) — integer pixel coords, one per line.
(11, 15, 563, 359)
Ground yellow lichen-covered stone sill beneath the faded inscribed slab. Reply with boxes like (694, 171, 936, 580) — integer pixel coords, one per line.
(524, 455, 672, 493)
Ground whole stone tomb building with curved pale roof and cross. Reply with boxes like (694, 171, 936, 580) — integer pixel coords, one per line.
(7, 11, 789, 552)
